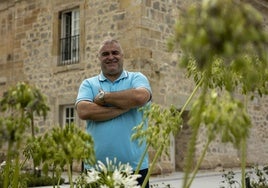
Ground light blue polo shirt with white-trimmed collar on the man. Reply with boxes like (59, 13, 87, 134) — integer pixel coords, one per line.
(76, 71, 151, 170)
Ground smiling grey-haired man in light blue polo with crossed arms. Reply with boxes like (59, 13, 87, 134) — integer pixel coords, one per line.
(76, 39, 152, 188)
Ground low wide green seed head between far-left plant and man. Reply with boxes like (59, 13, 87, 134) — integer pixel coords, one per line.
(25, 124, 95, 187)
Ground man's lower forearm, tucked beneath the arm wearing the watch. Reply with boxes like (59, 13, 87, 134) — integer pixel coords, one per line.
(77, 101, 128, 121)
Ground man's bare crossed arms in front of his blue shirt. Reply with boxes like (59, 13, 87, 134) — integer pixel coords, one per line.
(76, 88, 151, 121)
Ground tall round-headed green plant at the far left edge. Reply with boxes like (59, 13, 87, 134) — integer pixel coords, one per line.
(0, 82, 49, 188)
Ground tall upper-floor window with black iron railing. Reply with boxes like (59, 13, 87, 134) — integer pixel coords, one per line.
(59, 9, 80, 65)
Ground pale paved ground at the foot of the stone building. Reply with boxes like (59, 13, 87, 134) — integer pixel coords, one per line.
(31, 171, 243, 188)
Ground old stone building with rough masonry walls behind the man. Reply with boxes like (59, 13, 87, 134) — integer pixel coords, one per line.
(0, 0, 268, 173)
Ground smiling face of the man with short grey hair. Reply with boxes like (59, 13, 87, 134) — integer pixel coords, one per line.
(99, 43, 123, 78)
